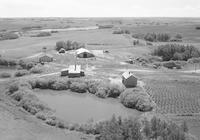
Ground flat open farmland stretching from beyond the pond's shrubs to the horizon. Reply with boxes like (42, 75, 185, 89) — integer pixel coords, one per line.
(0, 18, 200, 138)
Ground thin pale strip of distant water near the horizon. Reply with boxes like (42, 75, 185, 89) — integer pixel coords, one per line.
(30, 26, 99, 33)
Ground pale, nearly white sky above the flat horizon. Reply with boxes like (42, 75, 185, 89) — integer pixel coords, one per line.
(0, 0, 200, 17)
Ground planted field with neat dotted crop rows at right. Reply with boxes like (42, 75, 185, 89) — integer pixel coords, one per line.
(146, 80, 200, 115)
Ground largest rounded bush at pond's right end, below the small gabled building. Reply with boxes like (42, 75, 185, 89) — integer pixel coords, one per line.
(120, 87, 153, 111)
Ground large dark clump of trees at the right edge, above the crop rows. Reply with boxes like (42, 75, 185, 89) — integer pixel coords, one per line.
(153, 44, 200, 61)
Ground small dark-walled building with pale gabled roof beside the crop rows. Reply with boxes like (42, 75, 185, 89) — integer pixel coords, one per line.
(122, 72, 137, 88)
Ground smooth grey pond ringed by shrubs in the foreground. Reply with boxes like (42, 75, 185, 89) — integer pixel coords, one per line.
(35, 89, 141, 123)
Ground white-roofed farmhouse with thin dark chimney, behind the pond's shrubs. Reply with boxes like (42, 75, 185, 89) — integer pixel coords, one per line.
(68, 65, 84, 78)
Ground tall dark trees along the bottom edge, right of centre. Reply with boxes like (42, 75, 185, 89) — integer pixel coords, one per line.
(96, 116, 192, 140)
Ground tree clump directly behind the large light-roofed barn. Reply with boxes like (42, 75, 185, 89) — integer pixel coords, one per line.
(55, 40, 85, 51)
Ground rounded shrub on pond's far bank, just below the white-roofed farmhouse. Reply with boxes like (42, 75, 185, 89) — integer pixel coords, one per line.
(70, 82, 87, 93)
